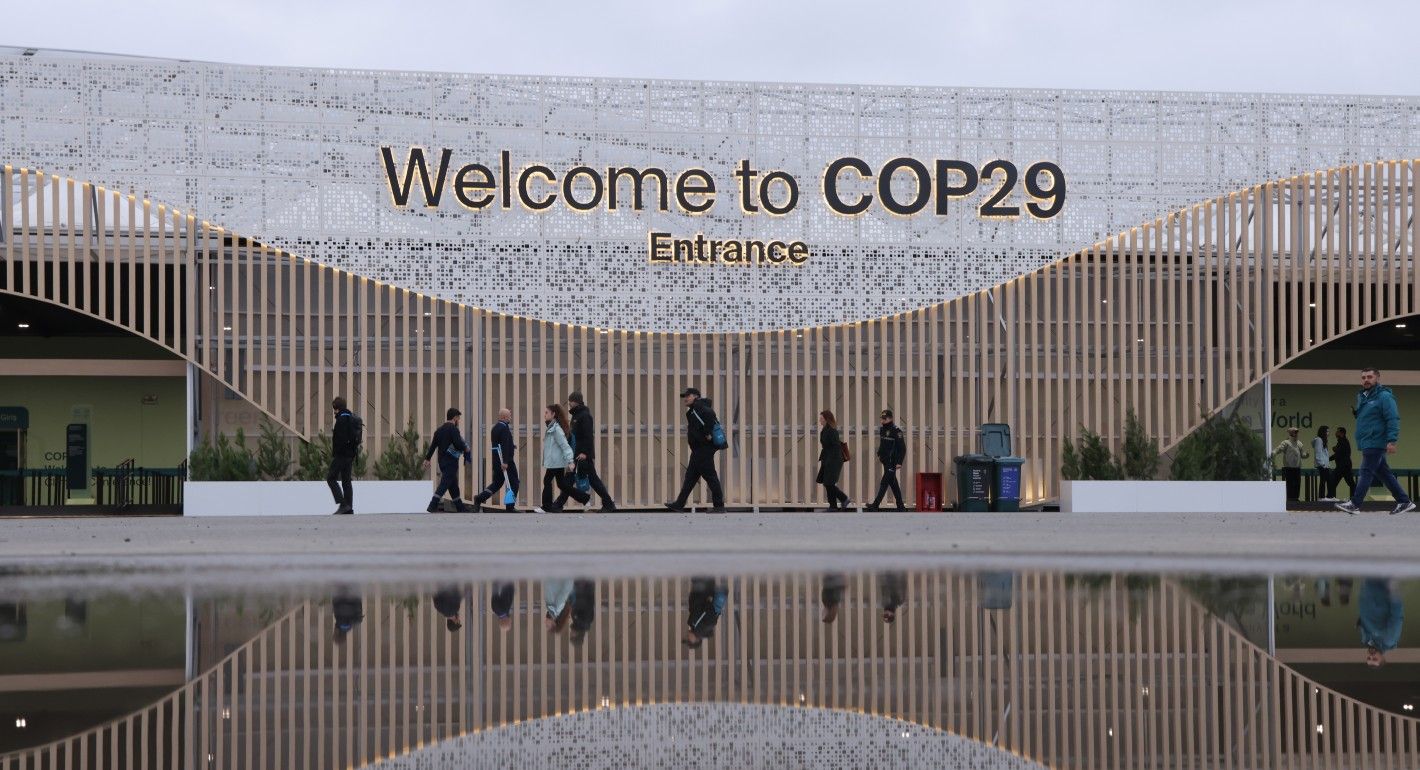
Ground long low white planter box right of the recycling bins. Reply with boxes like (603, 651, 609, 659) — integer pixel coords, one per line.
(1061, 482, 1287, 513)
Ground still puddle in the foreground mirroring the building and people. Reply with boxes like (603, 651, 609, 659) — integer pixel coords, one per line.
(0, 571, 1420, 770)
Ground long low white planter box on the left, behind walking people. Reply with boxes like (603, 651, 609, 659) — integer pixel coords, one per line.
(182, 480, 435, 516)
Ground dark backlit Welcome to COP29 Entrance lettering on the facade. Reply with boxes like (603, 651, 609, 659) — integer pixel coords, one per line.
(379, 146, 1065, 266)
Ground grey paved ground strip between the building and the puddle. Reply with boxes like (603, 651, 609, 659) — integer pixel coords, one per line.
(0, 513, 1420, 588)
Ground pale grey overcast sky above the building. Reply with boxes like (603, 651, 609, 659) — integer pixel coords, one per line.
(8, 0, 1420, 94)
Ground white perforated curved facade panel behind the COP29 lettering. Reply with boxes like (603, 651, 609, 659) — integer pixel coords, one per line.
(0, 50, 1420, 331)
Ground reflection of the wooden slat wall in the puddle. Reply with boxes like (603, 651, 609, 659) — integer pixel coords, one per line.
(0, 573, 1420, 769)
